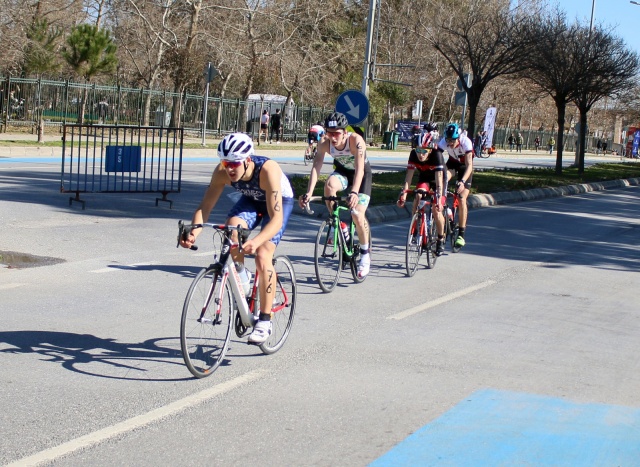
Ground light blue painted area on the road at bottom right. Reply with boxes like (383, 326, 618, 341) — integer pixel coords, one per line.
(370, 389, 640, 467)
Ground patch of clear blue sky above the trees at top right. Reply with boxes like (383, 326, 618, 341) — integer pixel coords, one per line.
(551, 0, 640, 55)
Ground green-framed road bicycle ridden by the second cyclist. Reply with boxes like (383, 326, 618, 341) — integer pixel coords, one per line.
(305, 196, 371, 293)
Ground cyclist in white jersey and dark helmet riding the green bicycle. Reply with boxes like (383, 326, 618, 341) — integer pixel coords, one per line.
(298, 112, 371, 277)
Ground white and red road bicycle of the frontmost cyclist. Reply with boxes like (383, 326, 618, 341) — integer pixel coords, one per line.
(178, 221, 297, 378)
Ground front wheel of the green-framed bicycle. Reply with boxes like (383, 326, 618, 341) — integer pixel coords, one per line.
(313, 218, 342, 293)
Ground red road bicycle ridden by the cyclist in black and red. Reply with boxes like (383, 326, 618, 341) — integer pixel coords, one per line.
(404, 188, 438, 277)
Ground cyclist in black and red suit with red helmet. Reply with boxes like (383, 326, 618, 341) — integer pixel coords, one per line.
(397, 123, 447, 256)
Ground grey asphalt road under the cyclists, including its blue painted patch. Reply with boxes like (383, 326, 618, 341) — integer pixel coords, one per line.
(0, 156, 640, 466)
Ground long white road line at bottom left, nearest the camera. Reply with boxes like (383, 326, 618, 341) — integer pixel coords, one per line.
(7, 370, 266, 467)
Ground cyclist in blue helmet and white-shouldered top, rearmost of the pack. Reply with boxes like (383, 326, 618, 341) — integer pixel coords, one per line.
(438, 123, 473, 247)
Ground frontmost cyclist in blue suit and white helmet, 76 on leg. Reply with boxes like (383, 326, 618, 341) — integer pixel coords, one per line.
(180, 133, 294, 344)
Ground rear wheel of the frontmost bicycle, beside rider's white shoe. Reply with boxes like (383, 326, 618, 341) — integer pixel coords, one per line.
(260, 256, 297, 355)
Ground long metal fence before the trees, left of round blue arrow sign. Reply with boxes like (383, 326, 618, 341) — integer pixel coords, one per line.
(0, 77, 331, 141)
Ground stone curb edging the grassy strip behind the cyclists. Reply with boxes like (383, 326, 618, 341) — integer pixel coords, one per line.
(293, 178, 640, 224)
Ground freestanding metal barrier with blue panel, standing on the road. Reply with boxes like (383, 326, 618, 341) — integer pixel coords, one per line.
(60, 124, 184, 209)
